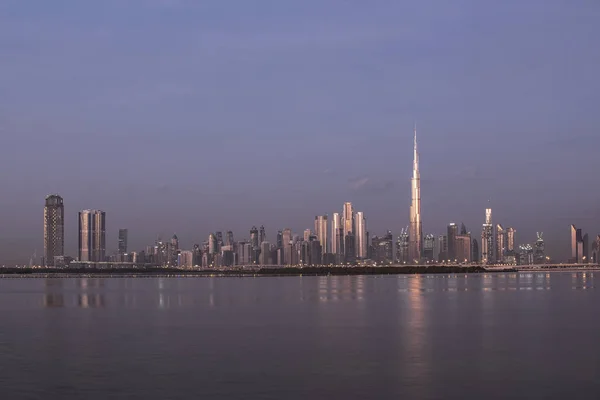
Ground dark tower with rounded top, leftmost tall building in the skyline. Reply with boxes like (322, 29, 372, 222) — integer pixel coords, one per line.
(43, 194, 65, 267)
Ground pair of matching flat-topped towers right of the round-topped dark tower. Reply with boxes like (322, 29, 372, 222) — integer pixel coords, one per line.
(79, 210, 106, 262)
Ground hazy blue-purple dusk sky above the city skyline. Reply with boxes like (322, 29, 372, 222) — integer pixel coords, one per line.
(0, 0, 600, 264)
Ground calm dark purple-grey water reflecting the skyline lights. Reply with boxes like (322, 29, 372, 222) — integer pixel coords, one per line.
(0, 272, 600, 399)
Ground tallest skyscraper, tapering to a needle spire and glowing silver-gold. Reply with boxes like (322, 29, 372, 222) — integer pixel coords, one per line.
(408, 124, 423, 263)
